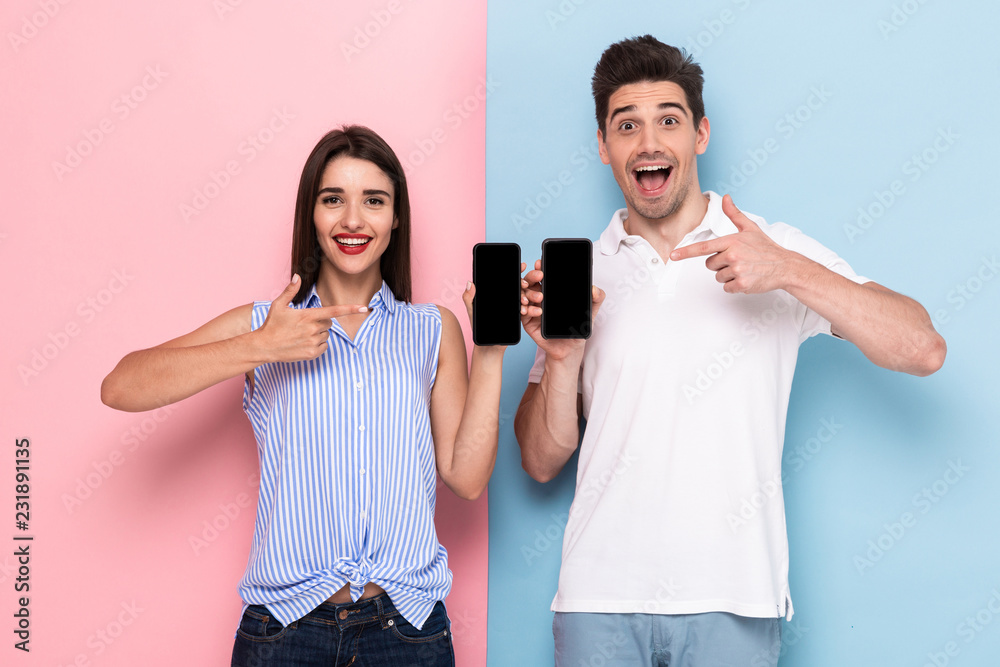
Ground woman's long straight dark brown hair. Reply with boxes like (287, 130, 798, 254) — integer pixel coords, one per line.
(291, 125, 413, 303)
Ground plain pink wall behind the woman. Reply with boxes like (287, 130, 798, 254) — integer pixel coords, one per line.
(0, 0, 487, 666)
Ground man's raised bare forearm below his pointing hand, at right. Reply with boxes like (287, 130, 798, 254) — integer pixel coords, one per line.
(785, 255, 946, 375)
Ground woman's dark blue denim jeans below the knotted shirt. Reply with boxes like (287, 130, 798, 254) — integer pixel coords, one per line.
(232, 594, 455, 667)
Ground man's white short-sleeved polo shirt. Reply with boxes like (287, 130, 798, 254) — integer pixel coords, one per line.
(529, 192, 867, 619)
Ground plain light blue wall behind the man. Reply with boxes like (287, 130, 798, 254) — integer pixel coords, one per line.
(486, 0, 1000, 667)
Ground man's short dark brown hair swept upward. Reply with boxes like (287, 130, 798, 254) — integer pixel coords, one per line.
(591, 35, 705, 135)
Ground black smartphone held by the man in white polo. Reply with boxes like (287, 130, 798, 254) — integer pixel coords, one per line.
(542, 239, 594, 338)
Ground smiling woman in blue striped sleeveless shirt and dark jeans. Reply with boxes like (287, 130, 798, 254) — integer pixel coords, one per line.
(101, 126, 512, 666)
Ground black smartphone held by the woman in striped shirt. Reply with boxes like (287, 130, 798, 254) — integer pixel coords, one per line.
(472, 243, 521, 345)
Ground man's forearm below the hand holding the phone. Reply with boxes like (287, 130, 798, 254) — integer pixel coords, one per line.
(514, 359, 580, 482)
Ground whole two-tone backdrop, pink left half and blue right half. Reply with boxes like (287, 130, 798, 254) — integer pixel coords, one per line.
(0, 0, 1000, 667)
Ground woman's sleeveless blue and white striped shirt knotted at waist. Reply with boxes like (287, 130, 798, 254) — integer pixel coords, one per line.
(239, 282, 451, 628)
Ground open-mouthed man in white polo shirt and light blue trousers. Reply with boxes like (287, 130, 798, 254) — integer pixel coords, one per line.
(515, 35, 945, 667)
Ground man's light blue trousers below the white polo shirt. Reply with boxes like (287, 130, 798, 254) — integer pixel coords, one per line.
(552, 612, 781, 667)
